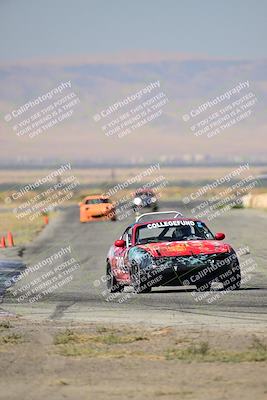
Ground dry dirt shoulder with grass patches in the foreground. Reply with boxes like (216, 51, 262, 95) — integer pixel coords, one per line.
(0, 317, 267, 400)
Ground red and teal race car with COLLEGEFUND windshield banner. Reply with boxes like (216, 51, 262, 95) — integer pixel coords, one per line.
(106, 211, 241, 293)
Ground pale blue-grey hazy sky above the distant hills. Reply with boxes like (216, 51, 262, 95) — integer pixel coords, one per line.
(0, 0, 267, 61)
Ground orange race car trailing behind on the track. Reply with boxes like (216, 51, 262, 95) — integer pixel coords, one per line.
(79, 195, 116, 222)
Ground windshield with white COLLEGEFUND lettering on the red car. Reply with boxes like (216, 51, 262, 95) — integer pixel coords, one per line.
(136, 220, 214, 244)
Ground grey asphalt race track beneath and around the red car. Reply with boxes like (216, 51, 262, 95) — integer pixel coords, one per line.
(1, 202, 267, 329)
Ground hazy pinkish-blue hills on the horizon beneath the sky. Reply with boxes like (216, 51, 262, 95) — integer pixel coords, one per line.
(0, 54, 267, 161)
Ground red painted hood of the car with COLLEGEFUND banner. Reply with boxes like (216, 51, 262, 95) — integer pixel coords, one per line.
(137, 240, 231, 257)
